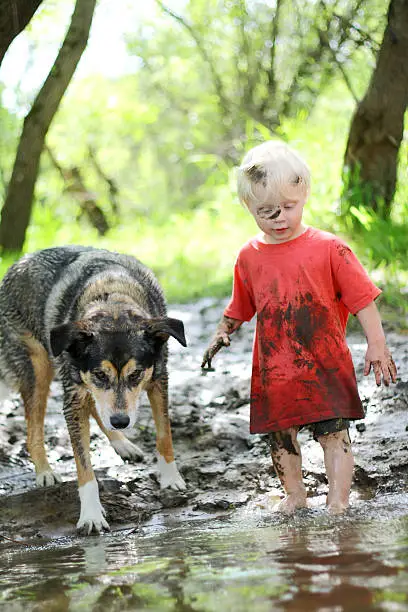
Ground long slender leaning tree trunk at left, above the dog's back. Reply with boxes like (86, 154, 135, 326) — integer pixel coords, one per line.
(0, 0, 96, 251)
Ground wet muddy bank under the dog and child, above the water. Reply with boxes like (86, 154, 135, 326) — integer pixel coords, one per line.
(0, 299, 408, 543)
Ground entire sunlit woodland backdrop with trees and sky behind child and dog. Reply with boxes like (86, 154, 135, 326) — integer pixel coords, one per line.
(0, 0, 408, 327)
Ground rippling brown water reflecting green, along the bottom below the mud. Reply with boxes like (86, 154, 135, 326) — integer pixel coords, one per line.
(0, 496, 408, 612)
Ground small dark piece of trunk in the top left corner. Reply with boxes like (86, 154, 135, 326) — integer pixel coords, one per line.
(0, 0, 42, 66)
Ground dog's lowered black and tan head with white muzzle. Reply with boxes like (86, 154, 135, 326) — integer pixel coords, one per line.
(50, 313, 187, 429)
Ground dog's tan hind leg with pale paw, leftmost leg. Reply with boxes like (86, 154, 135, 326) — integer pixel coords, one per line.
(20, 334, 61, 487)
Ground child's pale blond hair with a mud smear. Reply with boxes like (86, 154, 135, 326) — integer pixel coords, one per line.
(237, 140, 310, 205)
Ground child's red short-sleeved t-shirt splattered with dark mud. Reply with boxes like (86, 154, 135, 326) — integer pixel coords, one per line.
(224, 227, 381, 433)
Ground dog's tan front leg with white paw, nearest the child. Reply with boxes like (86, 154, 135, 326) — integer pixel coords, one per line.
(146, 379, 186, 490)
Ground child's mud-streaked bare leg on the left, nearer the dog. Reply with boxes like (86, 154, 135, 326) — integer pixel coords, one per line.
(269, 427, 307, 514)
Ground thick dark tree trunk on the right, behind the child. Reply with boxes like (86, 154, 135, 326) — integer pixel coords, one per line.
(343, 0, 408, 218)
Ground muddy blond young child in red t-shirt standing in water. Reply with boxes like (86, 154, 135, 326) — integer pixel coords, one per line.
(202, 141, 397, 514)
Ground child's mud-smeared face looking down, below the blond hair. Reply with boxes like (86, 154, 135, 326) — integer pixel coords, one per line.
(247, 185, 307, 244)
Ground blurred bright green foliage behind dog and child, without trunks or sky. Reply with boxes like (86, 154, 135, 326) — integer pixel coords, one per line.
(0, 0, 408, 326)
